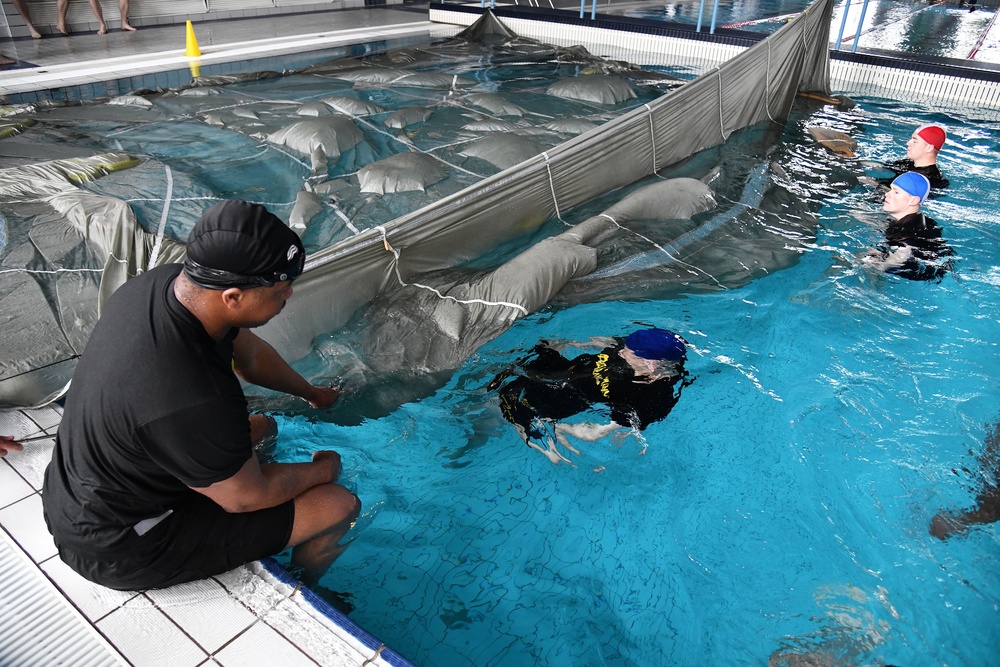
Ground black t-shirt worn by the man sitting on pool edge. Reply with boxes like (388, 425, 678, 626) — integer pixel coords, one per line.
(42, 264, 252, 554)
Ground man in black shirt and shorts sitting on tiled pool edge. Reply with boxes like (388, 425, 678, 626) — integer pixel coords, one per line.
(42, 200, 360, 590)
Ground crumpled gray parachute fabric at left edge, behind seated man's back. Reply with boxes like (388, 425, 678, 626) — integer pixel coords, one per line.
(0, 155, 184, 407)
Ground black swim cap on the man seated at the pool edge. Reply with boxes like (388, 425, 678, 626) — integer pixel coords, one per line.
(184, 199, 306, 289)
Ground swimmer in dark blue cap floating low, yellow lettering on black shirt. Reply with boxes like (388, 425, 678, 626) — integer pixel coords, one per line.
(489, 327, 691, 464)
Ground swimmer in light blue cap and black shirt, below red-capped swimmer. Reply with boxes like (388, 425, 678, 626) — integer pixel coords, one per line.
(864, 171, 953, 280)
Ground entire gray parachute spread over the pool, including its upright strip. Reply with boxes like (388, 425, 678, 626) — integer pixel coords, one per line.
(0, 0, 832, 405)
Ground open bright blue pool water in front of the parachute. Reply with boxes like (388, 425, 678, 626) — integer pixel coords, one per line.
(272, 99, 1000, 667)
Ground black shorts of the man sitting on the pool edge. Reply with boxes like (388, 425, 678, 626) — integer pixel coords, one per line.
(59, 493, 295, 590)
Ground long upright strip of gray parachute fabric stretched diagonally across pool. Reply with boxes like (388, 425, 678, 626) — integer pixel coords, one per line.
(262, 0, 833, 358)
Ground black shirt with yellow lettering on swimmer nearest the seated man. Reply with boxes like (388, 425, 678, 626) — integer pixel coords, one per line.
(490, 344, 687, 439)
